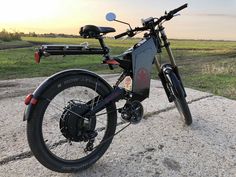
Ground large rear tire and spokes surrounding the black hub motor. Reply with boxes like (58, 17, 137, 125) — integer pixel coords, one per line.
(27, 74, 117, 172)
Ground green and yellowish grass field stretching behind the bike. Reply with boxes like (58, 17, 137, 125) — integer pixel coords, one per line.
(0, 37, 236, 99)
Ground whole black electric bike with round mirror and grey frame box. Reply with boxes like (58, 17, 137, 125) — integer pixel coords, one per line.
(24, 4, 192, 172)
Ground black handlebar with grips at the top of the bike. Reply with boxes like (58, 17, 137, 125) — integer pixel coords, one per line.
(114, 3, 188, 39)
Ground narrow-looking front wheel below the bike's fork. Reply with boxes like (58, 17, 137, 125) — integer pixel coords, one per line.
(167, 72, 192, 125)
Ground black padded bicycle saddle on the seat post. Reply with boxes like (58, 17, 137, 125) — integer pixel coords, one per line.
(79, 25, 116, 38)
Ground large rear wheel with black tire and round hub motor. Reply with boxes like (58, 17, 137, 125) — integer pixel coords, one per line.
(27, 74, 117, 172)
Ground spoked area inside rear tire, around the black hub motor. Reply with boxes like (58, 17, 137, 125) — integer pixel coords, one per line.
(41, 86, 113, 162)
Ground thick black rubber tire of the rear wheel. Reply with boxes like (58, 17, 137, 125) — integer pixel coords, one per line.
(27, 74, 117, 173)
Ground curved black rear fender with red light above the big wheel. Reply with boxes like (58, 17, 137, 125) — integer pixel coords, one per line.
(23, 69, 113, 121)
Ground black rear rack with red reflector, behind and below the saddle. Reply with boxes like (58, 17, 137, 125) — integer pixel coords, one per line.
(34, 43, 106, 63)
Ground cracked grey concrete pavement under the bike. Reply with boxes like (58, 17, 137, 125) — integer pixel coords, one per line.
(0, 75, 236, 177)
